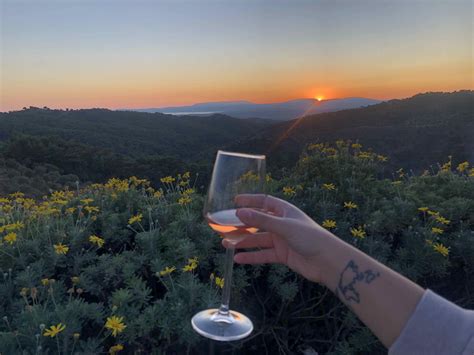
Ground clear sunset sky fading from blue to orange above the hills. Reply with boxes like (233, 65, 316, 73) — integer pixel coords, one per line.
(0, 0, 474, 111)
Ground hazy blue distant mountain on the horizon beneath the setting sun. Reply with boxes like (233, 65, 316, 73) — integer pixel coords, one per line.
(134, 97, 381, 121)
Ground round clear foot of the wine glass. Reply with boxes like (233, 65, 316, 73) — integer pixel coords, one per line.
(191, 308, 253, 341)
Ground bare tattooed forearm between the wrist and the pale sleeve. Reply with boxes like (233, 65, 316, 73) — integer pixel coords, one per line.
(322, 238, 424, 348)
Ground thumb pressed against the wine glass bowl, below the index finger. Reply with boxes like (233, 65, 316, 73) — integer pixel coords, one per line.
(237, 208, 292, 236)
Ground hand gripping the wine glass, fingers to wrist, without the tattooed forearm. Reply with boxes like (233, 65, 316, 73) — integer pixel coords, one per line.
(224, 194, 335, 282)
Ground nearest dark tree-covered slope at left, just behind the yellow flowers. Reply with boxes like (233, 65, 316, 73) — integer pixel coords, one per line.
(0, 135, 209, 197)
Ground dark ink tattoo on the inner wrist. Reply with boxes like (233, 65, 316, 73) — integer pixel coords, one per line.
(336, 260, 380, 303)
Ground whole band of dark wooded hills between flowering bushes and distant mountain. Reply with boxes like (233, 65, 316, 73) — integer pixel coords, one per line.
(0, 91, 474, 196)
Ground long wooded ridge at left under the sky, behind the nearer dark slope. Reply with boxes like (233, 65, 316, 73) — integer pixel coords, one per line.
(0, 108, 269, 160)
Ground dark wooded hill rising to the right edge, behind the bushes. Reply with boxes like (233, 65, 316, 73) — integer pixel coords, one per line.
(226, 90, 474, 170)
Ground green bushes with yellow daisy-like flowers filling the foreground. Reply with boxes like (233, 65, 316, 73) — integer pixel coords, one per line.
(0, 141, 474, 354)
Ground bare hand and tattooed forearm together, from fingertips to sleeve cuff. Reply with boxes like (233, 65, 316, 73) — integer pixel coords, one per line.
(228, 195, 424, 348)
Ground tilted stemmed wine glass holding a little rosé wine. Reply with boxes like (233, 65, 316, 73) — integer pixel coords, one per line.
(191, 150, 265, 341)
